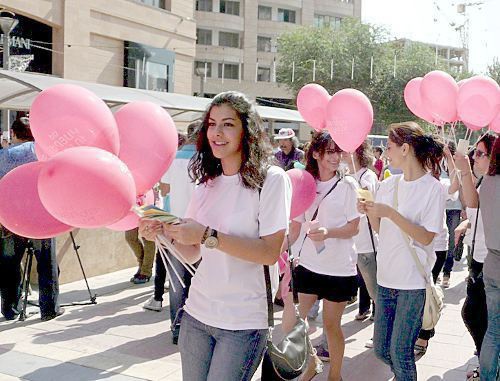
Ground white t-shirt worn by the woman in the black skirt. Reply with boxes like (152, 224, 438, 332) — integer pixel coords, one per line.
(292, 176, 360, 276)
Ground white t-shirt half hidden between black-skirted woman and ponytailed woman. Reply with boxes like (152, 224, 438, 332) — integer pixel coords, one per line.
(354, 168, 378, 254)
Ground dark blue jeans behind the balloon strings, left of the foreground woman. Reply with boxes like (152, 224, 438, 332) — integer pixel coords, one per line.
(164, 252, 192, 339)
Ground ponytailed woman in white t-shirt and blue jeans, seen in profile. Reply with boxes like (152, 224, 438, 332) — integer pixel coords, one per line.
(358, 122, 445, 381)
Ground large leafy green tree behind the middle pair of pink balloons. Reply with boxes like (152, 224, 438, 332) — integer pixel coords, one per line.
(277, 19, 469, 132)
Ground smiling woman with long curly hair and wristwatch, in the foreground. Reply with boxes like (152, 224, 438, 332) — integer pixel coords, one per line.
(141, 91, 291, 381)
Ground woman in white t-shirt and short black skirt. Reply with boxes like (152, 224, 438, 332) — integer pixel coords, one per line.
(283, 132, 360, 381)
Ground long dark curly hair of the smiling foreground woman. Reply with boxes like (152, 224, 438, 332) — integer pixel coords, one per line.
(189, 91, 272, 190)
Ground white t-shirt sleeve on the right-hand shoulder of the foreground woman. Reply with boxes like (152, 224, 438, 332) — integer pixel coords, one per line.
(259, 166, 292, 237)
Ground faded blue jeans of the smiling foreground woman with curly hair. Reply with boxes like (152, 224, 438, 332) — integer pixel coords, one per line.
(179, 312, 268, 381)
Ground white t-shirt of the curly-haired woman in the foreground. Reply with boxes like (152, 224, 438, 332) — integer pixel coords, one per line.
(185, 166, 292, 330)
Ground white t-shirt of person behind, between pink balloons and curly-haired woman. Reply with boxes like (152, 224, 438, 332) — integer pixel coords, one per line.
(160, 147, 194, 218)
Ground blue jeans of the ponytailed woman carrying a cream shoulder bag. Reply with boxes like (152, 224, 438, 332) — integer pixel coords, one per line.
(373, 286, 425, 381)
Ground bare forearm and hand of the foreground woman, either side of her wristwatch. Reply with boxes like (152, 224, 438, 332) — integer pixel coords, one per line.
(163, 219, 285, 265)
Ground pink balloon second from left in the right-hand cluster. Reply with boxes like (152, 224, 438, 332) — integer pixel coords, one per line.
(420, 70, 458, 125)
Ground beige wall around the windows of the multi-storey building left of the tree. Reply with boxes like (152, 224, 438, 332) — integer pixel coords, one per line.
(192, 0, 361, 99)
